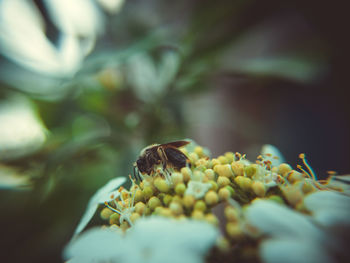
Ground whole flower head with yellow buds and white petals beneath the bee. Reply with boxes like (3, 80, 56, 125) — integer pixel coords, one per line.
(65, 143, 350, 263)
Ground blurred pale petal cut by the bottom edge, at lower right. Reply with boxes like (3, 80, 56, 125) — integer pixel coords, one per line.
(259, 237, 333, 263)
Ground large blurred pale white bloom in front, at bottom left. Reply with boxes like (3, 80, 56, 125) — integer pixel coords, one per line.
(64, 216, 218, 263)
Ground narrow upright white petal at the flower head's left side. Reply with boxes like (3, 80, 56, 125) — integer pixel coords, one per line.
(74, 177, 126, 236)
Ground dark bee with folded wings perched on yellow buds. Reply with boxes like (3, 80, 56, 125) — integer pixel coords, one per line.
(134, 141, 190, 180)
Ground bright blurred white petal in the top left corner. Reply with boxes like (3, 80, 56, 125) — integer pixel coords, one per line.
(0, 0, 65, 73)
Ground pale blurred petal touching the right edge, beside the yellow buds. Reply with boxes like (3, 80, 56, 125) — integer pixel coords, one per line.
(304, 191, 350, 226)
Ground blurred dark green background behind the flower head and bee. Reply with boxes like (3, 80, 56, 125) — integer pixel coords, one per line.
(0, 0, 350, 262)
